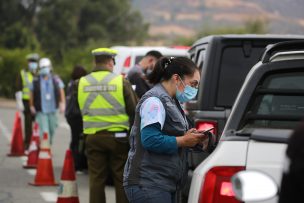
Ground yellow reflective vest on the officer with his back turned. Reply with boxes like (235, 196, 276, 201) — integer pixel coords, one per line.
(78, 71, 129, 134)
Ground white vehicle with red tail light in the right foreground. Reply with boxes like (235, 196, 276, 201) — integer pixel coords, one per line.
(188, 41, 304, 203)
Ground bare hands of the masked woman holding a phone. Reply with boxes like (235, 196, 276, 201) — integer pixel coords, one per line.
(176, 128, 208, 147)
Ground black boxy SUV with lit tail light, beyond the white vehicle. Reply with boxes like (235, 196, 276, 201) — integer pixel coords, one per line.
(185, 34, 304, 178)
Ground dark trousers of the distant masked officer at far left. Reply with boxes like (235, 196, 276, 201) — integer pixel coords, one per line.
(22, 99, 34, 149)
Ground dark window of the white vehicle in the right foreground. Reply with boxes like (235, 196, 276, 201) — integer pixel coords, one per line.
(243, 72, 304, 129)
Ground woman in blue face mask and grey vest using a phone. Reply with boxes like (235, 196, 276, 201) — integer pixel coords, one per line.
(123, 57, 207, 203)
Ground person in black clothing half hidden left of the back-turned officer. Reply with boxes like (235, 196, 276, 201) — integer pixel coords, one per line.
(65, 65, 87, 171)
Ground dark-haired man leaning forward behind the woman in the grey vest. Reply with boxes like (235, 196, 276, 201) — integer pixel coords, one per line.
(127, 50, 162, 98)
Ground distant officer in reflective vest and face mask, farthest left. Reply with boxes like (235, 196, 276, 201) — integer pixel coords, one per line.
(15, 53, 39, 149)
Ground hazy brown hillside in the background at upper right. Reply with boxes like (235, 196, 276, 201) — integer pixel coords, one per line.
(132, 0, 304, 38)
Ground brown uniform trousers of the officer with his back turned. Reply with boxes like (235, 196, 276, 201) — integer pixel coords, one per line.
(86, 131, 129, 203)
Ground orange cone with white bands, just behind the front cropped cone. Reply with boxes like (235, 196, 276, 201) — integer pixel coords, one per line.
(29, 133, 58, 186)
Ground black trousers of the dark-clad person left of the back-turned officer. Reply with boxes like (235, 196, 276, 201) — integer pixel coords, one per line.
(67, 117, 88, 171)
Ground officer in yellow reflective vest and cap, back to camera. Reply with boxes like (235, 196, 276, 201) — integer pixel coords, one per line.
(78, 48, 137, 203)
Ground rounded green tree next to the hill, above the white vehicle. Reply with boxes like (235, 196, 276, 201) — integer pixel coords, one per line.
(78, 0, 148, 43)
